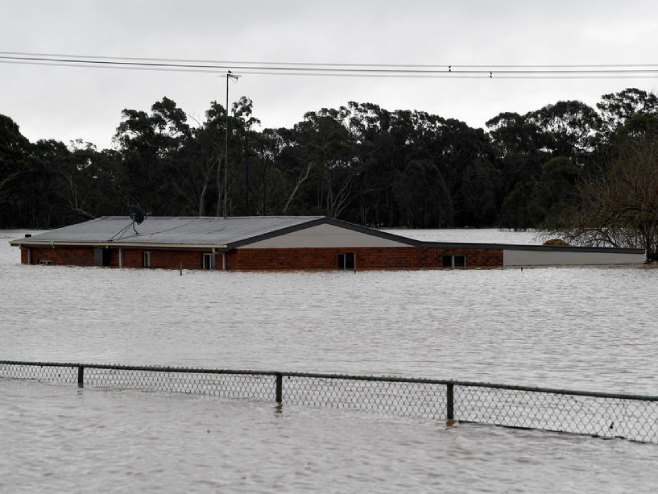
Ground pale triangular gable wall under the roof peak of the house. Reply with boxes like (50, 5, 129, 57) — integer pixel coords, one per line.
(241, 224, 409, 249)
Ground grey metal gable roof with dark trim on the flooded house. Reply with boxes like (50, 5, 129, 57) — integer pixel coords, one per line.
(10, 216, 419, 250)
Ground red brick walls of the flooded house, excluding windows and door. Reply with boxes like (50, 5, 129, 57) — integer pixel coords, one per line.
(21, 247, 503, 271)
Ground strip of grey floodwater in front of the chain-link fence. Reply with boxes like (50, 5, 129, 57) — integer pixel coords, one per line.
(0, 381, 658, 494)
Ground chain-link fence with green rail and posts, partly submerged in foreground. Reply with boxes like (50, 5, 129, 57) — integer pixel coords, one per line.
(0, 361, 658, 444)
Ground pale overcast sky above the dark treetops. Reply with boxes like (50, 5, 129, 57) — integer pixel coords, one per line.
(0, 0, 658, 148)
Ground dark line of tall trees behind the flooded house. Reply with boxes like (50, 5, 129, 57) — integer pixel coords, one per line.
(0, 88, 658, 229)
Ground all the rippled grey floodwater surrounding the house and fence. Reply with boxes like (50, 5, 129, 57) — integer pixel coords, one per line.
(0, 230, 658, 492)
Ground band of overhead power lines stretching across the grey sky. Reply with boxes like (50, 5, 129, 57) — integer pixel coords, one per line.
(0, 52, 658, 79)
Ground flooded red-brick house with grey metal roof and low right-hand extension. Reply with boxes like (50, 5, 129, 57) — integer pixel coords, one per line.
(10, 216, 644, 271)
